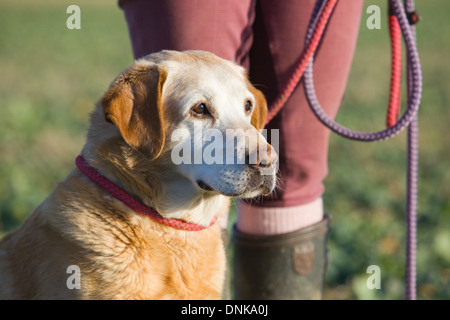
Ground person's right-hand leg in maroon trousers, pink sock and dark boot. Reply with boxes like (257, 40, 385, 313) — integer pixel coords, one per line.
(234, 0, 363, 299)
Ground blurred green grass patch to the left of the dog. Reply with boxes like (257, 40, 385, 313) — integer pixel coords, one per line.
(0, 1, 133, 231)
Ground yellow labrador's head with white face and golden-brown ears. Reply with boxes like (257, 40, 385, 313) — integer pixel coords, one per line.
(101, 51, 277, 198)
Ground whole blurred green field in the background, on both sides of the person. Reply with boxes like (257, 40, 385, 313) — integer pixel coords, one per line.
(0, 0, 450, 299)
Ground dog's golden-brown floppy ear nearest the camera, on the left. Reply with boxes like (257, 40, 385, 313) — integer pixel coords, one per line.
(101, 62, 167, 159)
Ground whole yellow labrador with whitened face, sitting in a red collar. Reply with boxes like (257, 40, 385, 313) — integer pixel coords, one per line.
(0, 51, 277, 299)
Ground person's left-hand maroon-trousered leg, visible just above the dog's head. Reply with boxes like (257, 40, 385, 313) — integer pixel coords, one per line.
(119, 0, 254, 67)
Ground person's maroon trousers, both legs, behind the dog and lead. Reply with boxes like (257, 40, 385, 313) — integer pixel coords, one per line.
(119, 0, 363, 207)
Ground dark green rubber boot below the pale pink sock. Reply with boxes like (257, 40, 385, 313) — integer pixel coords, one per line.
(232, 216, 330, 300)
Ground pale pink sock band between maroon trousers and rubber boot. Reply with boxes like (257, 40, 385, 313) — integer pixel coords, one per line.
(236, 197, 323, 235)
